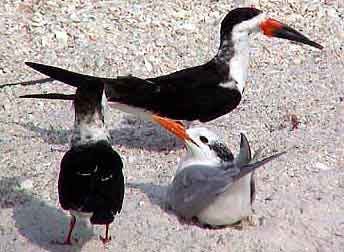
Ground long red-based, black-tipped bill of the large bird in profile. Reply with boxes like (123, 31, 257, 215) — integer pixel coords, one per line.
(260, 18, 323, 49)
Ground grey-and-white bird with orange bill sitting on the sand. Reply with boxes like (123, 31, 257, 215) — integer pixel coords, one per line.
(153, 118, 285, 227)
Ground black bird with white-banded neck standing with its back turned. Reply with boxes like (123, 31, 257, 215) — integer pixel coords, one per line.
(58, 83, 124, 244)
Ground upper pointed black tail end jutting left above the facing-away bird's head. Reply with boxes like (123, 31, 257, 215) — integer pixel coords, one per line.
(25, 62, 102, 87)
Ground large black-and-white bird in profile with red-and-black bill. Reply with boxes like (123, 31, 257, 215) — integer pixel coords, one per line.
(20, 8, 323, 122)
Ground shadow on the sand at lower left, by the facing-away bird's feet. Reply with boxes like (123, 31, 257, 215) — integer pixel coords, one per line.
(0, 177, 93, 252)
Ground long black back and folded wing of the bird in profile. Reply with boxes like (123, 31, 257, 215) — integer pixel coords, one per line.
(26, 60, 241, 122)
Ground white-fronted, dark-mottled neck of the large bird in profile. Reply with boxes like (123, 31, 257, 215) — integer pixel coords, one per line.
(215, 31, 249, 94)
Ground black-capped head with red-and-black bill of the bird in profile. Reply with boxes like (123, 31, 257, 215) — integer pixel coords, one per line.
(221, 7, 323, 49)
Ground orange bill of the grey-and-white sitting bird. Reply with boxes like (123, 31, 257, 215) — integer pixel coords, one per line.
(152, 115, 198, 146)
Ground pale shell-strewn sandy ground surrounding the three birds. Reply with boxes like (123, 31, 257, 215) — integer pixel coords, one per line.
(0, 0, 344, 252)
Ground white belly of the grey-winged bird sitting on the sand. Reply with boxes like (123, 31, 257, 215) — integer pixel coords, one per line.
(197, 174, 252, 226)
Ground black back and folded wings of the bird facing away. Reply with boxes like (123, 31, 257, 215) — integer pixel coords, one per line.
(58, 142, 124, 224)
